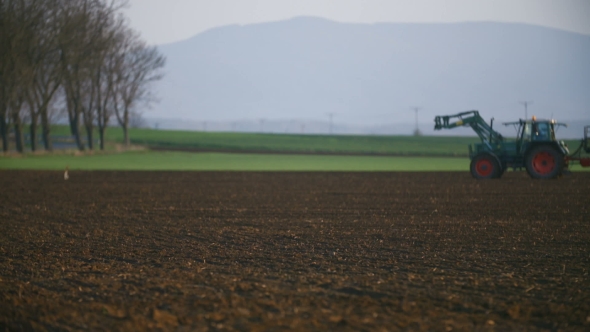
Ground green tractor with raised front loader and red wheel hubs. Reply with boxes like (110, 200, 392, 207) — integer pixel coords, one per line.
(434, 111, 590, 179)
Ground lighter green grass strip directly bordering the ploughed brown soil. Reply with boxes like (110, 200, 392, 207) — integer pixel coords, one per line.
(0, 152, 469, 171)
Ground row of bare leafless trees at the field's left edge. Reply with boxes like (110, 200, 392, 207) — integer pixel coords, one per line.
(0, 0, 165, 153)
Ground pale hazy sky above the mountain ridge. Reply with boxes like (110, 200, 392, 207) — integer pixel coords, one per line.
(125, 0, 590, 44)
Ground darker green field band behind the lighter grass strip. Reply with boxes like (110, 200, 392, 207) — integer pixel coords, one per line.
(102, 128, 479, 157)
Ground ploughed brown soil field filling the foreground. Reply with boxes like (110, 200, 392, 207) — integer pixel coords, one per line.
(0, 171, 590, 331)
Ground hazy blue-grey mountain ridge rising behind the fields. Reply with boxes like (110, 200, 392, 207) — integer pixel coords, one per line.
(151, 17, 590, 136)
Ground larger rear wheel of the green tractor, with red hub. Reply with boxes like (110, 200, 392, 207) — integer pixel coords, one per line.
(525, 145, 564, 179)
